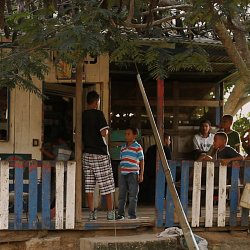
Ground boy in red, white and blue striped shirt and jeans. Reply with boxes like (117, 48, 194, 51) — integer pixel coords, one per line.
(116, 128, 144, 220)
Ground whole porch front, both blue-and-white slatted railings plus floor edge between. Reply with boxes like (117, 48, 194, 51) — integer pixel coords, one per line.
(0, 161, 250, 231)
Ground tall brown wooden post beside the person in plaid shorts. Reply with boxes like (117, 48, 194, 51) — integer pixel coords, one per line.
(75, 61, 83, 224)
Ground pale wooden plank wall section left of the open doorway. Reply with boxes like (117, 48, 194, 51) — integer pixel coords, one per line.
(0, 80, 42, 160)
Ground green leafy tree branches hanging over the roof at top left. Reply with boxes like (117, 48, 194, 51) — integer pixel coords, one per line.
(0, 0, 215, 93)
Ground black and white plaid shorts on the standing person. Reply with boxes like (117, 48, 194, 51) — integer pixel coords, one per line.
(83, 153, 115, 195)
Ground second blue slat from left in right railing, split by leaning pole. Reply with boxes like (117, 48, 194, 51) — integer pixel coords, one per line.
(166, 161, 177, 227)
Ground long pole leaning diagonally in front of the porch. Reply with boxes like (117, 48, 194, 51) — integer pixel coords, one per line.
(137, 70, 199, 249)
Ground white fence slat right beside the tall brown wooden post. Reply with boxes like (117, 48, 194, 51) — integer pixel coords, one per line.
(66, 161, 76, 229)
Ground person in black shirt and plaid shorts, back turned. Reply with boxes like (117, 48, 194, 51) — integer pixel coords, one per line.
(83, 91, 115, 221)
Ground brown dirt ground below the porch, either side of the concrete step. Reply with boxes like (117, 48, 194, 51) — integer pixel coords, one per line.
(0, 228, 250, 250)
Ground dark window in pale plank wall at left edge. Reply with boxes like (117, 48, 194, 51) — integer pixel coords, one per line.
(0, 87, 9, 141)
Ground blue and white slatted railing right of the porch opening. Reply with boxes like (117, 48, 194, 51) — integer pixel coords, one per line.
(156, 161, 250, 227)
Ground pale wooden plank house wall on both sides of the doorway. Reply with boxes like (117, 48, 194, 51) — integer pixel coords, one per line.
(0, 55, 109, 160)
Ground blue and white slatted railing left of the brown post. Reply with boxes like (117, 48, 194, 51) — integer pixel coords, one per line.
(0, 161, 76, 230)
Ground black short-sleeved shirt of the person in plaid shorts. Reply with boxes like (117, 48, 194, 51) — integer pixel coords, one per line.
(82, 109, 109, 155)
